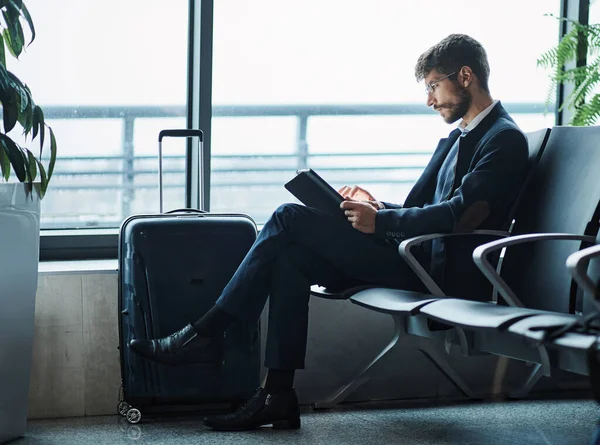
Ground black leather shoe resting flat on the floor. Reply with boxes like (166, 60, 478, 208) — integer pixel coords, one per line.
(204, 388, 300, 431)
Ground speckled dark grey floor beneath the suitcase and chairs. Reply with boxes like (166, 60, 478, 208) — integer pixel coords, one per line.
(13, 400, 600, 445)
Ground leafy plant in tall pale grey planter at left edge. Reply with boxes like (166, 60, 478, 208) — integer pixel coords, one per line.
(0, 0, 56, 443)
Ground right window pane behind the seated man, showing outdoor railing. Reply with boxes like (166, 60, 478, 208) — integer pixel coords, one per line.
(211, 0, 560, 222)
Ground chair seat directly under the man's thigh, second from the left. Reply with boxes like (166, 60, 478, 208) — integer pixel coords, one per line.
(350, 287, 439, 315)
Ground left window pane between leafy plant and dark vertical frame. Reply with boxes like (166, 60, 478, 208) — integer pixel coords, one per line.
(11, 0, 188, 228)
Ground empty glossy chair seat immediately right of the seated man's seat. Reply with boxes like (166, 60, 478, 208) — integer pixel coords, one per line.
(420, 298, 548, 331)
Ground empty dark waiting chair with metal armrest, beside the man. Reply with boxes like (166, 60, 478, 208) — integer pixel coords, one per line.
(419, 127, 600, 397)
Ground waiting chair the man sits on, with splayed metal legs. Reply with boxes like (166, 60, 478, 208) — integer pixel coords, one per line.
(311, 129, 550, 407)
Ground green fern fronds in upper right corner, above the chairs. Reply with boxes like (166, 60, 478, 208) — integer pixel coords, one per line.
(537, 5, 600, 126)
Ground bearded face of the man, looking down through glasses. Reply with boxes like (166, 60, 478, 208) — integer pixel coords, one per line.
(424, 69, 472, 124)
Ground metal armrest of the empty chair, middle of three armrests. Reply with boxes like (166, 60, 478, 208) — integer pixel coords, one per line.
(473, 233, 596, 307)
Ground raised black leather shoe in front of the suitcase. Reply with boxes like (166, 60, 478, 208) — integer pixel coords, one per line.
(129, 324, 223, 365)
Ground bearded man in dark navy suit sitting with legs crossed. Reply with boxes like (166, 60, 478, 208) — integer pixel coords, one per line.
(130, 34, 528, 430)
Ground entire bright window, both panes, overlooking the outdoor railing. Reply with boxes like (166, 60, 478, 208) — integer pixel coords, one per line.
(11, 0, 560, 253)
